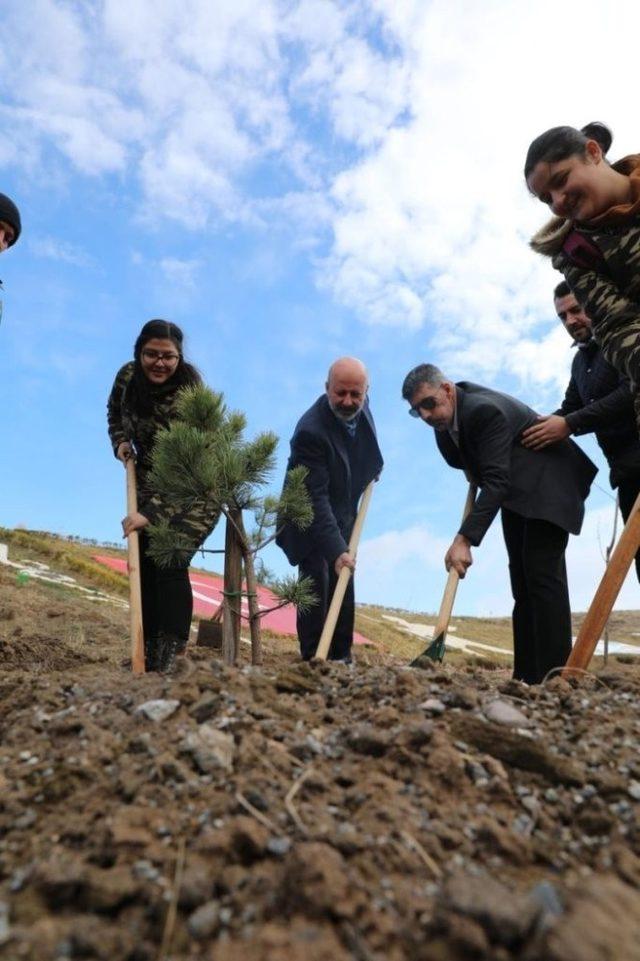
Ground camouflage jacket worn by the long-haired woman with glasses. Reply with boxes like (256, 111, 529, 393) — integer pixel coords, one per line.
(107, 361, 218, 548)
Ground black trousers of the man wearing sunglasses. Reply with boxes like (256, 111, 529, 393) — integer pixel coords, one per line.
(502, 508, 571, 684)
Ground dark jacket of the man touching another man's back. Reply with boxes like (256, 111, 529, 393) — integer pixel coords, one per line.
(556, 340, 640, 487)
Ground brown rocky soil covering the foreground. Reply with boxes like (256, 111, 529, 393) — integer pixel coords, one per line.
(0, 560, 640, 961)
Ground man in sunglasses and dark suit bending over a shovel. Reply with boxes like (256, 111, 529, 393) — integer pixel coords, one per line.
(402, 364, 597, 684)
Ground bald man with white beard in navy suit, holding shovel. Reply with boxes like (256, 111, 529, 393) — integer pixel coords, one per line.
(276, 357, 383, 663)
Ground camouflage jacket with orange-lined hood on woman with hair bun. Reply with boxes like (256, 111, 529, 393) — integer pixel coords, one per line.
(531, 157, 640, 415)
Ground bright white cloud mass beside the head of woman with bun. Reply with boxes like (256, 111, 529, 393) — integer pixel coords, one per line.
(322, 0, 638, 384)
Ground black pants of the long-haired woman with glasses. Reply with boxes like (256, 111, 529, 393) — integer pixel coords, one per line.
(140, 532, 193, 653)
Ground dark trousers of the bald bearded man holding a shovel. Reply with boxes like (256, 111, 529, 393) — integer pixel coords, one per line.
(297, 554, 355, 661)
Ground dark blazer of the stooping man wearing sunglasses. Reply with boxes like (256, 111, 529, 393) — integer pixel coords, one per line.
(436, 381, 598, 546)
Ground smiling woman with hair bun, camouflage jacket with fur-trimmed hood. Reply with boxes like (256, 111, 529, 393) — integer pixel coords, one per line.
(525, 123, 640, 425)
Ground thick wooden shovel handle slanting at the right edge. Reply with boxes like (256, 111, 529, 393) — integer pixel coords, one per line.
(562, 494, 640, 677)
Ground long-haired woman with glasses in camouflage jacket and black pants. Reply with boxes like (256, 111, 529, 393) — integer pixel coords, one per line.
(107, 320, 217, 671)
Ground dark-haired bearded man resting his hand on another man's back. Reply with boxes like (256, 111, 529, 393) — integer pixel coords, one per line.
(522, 280, 640, 580)
